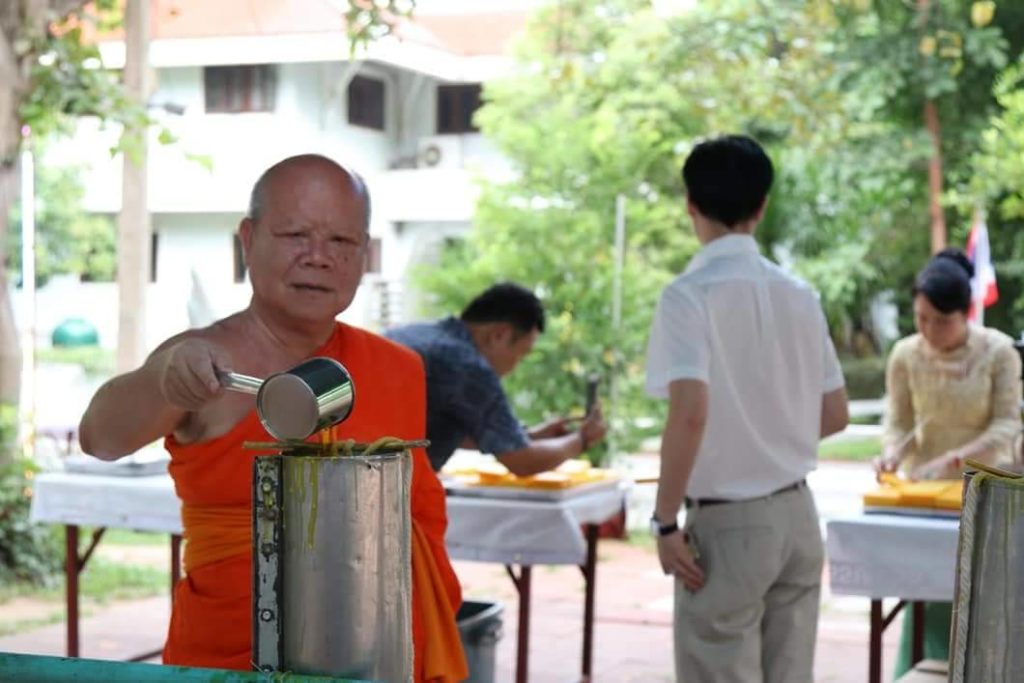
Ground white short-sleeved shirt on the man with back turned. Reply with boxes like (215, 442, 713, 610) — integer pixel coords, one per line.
(647, 234, 844, 499)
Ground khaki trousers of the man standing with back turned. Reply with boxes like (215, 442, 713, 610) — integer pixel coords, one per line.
(675, 486, 824, 683)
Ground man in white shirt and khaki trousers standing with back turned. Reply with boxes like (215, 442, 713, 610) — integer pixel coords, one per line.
(647, 135, 849, 683)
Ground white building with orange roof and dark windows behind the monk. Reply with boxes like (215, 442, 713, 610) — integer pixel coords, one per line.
(28, 0, 536, 348)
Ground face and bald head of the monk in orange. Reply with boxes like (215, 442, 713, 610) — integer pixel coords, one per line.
(241, 162, 368, 324)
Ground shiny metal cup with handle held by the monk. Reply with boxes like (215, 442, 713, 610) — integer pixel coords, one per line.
(217, 356, 355, 441)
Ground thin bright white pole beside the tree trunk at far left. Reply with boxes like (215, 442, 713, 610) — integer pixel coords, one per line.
(19, 134, 36, 457)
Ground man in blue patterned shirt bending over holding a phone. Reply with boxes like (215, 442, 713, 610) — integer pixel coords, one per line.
(385, 283, 607, 476)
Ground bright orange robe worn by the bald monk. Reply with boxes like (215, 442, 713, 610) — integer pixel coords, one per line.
(164, 323, 462, 680)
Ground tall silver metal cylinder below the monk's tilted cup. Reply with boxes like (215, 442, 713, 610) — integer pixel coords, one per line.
(281, 453, 413, 682)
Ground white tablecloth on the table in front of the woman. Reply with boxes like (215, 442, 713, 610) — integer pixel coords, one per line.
(826, 514, 959, 601)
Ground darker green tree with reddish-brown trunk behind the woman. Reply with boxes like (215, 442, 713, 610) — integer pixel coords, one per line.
(823, 0, 1024, 333)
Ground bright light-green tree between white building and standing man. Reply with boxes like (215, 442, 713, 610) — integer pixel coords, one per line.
(420, 0, 841, 454)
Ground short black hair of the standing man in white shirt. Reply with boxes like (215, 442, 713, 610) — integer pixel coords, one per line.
(683, 135, 775, 227)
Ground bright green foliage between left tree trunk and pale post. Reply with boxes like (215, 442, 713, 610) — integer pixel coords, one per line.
(8, 164, 117, 286)
